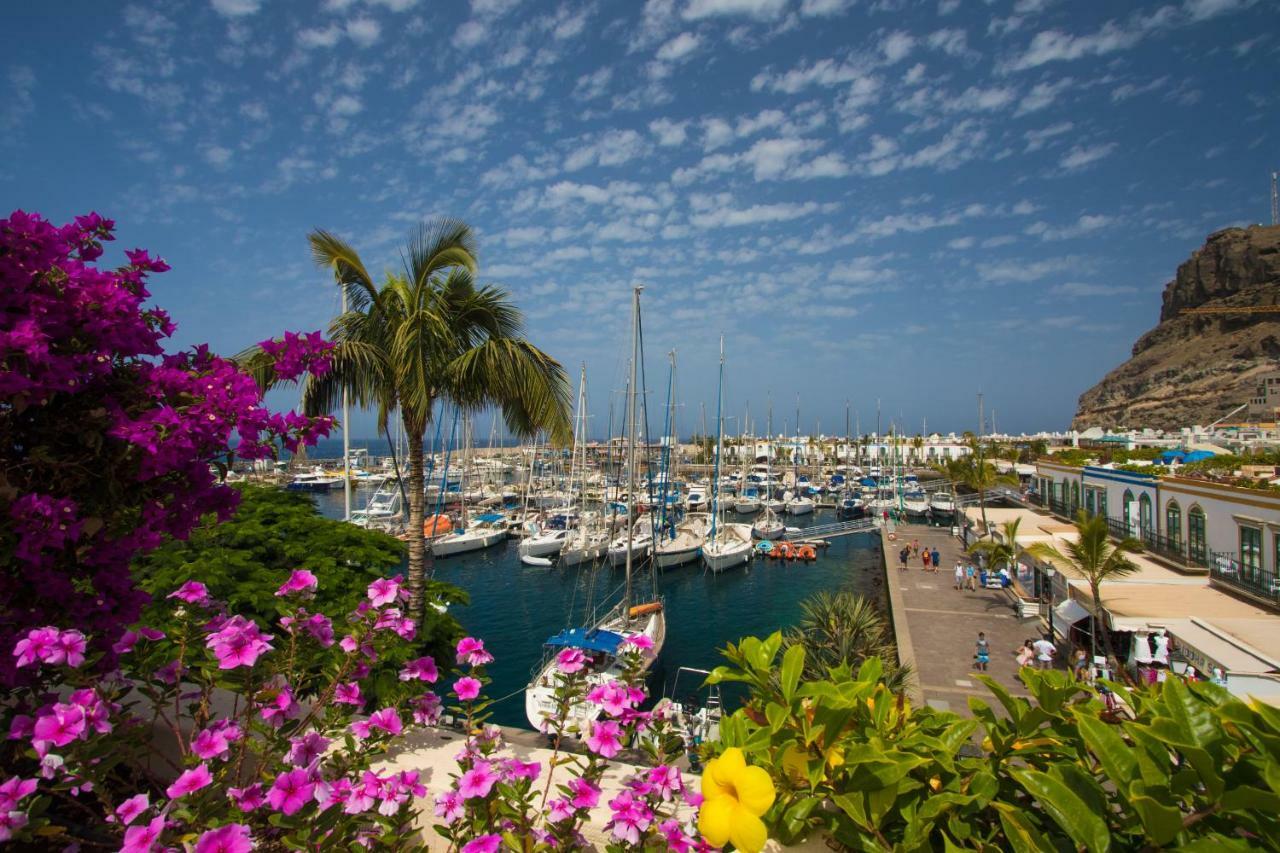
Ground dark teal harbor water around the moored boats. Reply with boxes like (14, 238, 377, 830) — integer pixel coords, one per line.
(314, 491, 883, 727)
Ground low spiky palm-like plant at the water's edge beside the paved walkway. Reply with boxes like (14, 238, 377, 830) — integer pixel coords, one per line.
(782, 592, 911, 693)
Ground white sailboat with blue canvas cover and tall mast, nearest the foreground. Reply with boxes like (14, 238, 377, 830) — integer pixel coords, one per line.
(525, 287, 667, 736)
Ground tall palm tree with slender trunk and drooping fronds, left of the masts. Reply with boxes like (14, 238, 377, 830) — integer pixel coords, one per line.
(253, 218, 570, 613)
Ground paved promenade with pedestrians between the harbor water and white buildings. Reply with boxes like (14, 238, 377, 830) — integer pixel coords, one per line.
(884, 524, 1061, 716)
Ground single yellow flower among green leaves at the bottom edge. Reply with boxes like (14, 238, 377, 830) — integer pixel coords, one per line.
(698, 747, 774, 853)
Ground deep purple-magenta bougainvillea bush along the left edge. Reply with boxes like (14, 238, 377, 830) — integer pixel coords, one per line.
(0, 210, 333, 684)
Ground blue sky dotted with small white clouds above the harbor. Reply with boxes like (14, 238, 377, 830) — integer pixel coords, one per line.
(0, 0, 1280, 437)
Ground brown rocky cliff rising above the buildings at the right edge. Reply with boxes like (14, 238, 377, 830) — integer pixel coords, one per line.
(1073, 225, 1280, 429)
